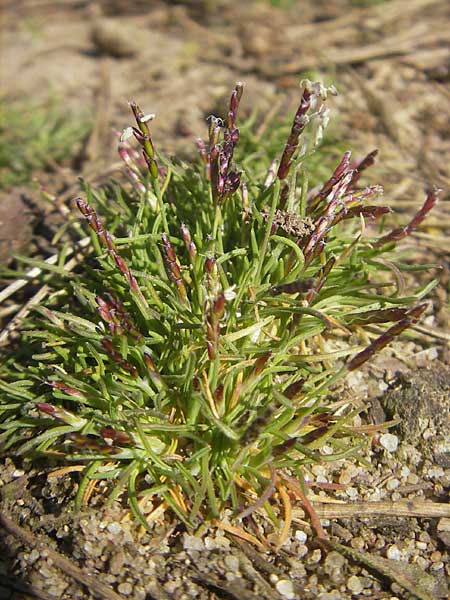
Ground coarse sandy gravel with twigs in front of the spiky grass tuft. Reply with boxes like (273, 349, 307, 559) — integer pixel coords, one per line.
(0, 353, 450, 600)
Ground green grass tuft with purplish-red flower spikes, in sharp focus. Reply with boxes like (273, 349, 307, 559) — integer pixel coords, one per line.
(0, 81, 438, 528)
